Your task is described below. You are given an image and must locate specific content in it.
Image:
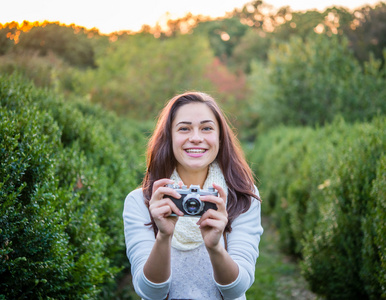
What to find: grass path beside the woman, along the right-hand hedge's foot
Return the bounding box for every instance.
[247,217,322,300]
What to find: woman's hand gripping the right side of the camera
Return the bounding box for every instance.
[197,184,228,251]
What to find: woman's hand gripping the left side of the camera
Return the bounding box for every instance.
[149,178,183,237]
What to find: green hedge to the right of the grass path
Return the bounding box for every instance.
[250,117,386,299]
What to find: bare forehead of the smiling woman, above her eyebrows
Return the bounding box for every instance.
[173,103,217,124]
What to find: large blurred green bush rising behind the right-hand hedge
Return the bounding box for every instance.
[246,34,386,132]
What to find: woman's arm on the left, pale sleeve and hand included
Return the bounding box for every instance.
[123,179,181,299]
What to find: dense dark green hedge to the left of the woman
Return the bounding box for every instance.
[0,75,147,299]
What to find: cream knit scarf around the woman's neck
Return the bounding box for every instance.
[170,161,228,251]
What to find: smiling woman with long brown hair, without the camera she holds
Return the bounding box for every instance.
[123,92,263,300]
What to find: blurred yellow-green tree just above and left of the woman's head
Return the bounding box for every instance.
[78,33,213,120]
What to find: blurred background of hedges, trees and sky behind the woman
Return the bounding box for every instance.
[0,0,386,299]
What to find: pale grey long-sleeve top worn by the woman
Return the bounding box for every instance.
[123,189,263,300]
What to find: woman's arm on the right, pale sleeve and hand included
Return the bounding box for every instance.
[199,186,263,299]
